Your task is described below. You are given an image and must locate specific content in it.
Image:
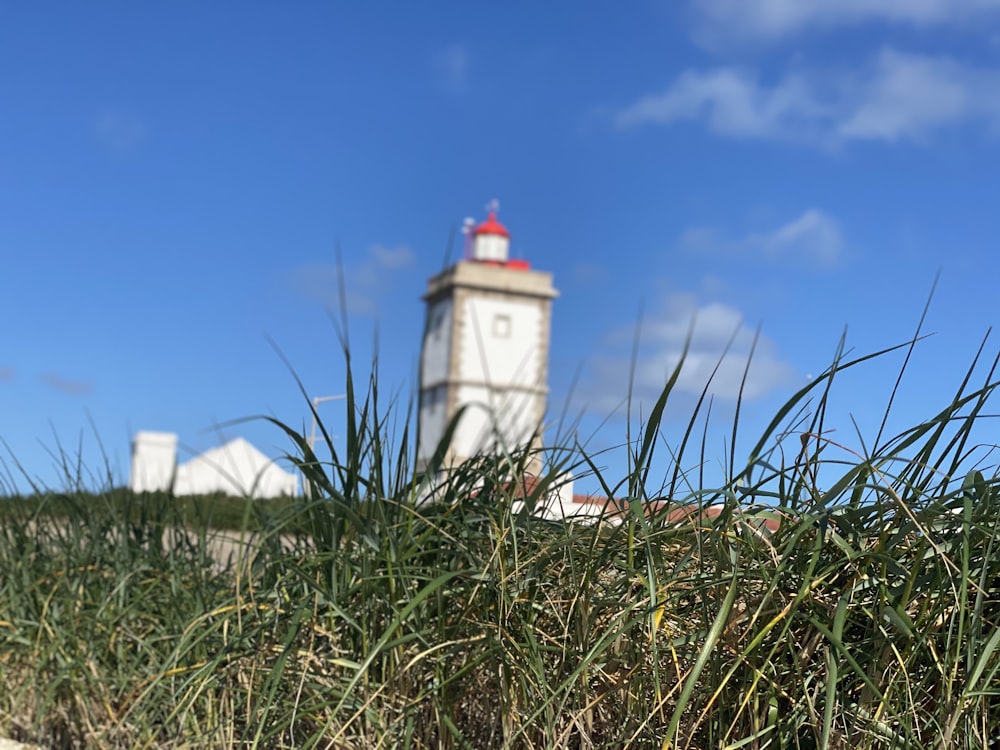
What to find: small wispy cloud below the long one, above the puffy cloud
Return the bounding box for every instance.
[679,208,844,268]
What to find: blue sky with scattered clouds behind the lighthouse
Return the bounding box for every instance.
[0,0,1000,496]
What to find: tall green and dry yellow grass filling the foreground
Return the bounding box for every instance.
[0,332,1000,750]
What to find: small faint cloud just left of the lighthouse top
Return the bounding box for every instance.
[291,245,417,315]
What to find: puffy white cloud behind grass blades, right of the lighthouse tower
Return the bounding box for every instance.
[585,294,796,412]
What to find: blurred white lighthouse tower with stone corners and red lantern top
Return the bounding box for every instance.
[417,201,558,473]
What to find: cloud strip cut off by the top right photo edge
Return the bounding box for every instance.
[691,0,1000,42]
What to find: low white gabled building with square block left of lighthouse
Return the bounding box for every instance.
[129,432,298,498]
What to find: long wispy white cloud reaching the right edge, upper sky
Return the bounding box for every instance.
[616,49,1000,146]
